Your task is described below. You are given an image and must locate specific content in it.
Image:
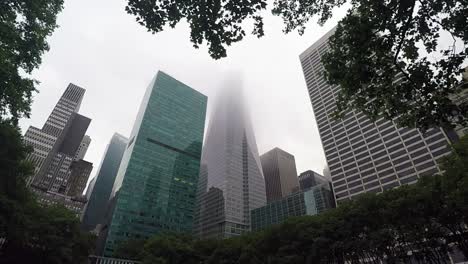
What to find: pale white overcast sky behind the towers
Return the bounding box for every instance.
[20,0,345,186]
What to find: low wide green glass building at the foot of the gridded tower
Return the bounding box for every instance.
[251,182,334,231]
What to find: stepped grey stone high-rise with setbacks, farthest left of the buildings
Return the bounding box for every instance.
[24,84,93,214]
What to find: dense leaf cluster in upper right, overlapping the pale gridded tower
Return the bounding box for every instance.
[324,0,468,128]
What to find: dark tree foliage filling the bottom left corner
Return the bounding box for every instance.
[0,120,94,264]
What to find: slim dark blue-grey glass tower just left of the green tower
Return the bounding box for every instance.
[82,133,128,230]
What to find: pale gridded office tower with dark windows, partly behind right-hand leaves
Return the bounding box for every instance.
[299,30,450,202]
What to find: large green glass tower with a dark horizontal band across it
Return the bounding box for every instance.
[104,72,207,255]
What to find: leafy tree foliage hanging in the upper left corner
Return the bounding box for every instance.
[0,0,63,123]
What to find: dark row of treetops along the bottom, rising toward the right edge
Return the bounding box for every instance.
[114,137,468,264]
